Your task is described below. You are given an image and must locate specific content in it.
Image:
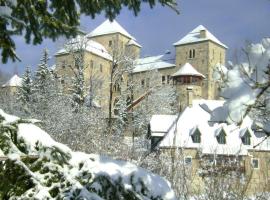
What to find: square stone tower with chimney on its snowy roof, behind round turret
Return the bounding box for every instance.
[174,25,227,99]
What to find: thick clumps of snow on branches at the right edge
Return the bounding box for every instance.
[213,38,270,135]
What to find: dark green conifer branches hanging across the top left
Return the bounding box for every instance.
[0,0,176,63]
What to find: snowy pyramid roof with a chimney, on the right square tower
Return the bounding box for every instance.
[173,25,228,49]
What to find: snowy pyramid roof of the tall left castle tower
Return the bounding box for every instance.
[87,19,135,39]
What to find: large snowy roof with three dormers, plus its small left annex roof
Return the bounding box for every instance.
[150,100,270,155]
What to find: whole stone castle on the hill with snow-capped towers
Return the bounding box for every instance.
[55,20,227,110]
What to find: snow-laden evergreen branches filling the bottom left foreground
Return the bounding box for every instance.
[0,110,176,200]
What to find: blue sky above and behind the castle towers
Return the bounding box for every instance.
[0,0,270,74]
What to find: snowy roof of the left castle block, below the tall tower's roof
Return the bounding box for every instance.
[55,35,112,60]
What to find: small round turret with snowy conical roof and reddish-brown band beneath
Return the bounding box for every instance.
[172,63,205,110]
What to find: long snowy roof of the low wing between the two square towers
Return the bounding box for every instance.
[133,55,175,73]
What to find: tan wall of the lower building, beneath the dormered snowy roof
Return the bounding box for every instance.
[161,148,270,196]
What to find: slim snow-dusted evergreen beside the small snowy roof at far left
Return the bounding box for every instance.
[18,66,33,108]
